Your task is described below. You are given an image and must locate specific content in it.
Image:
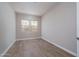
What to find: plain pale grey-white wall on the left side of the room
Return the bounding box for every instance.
[0,2,15,55]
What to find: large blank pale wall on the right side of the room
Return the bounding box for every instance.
[42,2,77,54]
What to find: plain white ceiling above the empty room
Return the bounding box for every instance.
[10,2,56,16]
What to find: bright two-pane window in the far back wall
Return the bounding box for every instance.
[21,20,38,31]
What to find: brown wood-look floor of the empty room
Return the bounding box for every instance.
[4,39,73,57]
